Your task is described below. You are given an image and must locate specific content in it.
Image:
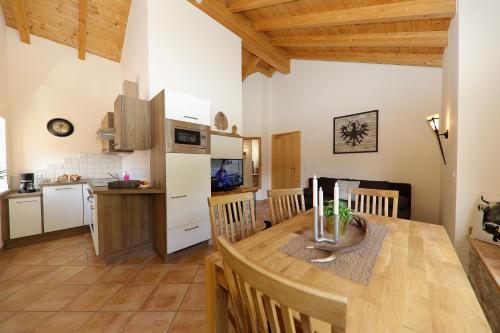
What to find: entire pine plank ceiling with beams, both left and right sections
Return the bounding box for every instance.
[0,0,456,79]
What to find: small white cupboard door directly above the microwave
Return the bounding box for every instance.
[165,90,210,125]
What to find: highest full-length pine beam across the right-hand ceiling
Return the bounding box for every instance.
[253,0,456,31]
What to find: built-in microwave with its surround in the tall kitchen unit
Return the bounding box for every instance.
[165,119,210,154]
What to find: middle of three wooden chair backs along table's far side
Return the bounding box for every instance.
[267,188,306,225]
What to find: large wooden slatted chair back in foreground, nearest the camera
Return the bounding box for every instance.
[219,237,347,333]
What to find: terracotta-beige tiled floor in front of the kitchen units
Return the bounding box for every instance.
[0,202,268,333]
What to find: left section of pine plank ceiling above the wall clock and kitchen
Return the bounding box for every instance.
[0,0,131,62]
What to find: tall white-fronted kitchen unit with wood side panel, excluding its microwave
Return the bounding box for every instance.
[149,90,211,255]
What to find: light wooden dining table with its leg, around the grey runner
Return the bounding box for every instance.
[205,210,491,333]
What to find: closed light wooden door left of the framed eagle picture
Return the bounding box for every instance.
[271,131,301,189]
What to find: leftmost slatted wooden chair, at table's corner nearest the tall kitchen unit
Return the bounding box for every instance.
[208,193,257,247]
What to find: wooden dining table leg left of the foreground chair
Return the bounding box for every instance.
[205,258,229,333]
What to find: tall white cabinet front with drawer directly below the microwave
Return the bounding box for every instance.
[166,153,211,253]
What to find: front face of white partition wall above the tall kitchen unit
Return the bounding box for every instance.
[149,0,242,133]
